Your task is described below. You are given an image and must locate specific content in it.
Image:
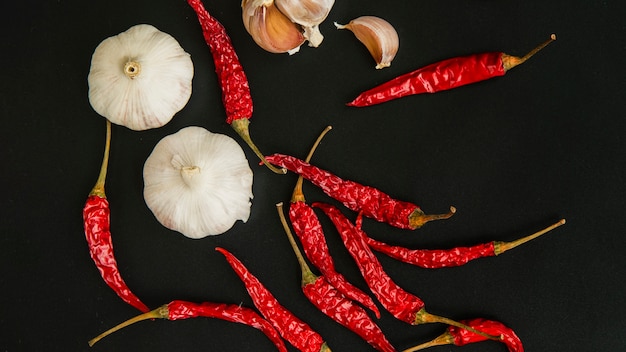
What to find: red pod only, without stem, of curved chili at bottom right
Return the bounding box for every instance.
[446,318,524,352]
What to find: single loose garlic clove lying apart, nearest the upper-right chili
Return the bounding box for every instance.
[335,16,400,69]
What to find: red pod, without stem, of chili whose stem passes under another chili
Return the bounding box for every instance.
[289,201,380,318]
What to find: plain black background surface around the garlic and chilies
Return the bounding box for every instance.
[0,0,626,352]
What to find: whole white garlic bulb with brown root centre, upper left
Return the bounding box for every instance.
[87,24,194,131]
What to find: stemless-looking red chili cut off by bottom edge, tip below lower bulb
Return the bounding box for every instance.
[215,247,330,352]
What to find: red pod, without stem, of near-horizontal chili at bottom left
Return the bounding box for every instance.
[167,300,287,352]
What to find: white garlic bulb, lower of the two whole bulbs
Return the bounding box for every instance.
[143,126,252,238]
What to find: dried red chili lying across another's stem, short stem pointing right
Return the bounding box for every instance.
[266,154,456,230]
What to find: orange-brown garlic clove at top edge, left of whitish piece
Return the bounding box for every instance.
[241,0,305,55]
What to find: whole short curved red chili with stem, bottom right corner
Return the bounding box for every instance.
[402,318,524,352]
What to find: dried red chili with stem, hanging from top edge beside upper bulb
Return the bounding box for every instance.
[187,0,286,174]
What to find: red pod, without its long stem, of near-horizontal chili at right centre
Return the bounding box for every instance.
[366,236,496,269]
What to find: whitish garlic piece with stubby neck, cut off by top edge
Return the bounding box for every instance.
[275,0,335,47]
